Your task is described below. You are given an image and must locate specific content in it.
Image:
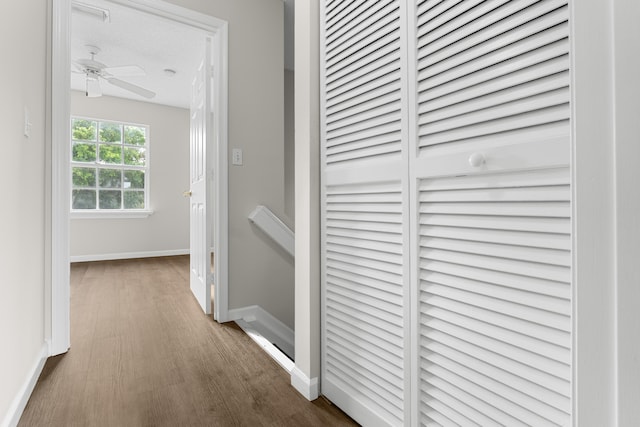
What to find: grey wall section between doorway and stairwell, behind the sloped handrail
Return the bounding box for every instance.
[165,0,294,328]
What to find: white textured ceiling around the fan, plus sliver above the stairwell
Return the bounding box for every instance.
[71,0,294,108]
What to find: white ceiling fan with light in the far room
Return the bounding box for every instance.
[72,45,156,99]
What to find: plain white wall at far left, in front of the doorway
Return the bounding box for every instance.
[0,0,47,425]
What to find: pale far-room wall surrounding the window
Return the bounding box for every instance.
[70,91,189,259]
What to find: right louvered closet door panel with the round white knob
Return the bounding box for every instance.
[410,0,572,426]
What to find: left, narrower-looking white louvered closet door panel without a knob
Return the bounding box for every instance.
[321,0,409,425]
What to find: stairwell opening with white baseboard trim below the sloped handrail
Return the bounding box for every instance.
[227,305,295,372]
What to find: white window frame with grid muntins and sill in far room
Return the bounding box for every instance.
[69,115,153,219]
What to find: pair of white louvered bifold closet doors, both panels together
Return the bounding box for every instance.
[321,0,573,425]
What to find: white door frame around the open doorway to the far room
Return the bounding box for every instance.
[50,0,229,356]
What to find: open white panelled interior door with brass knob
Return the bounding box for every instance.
[190,39,213,314]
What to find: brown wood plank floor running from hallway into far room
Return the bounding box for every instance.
[19,256,356,427]
